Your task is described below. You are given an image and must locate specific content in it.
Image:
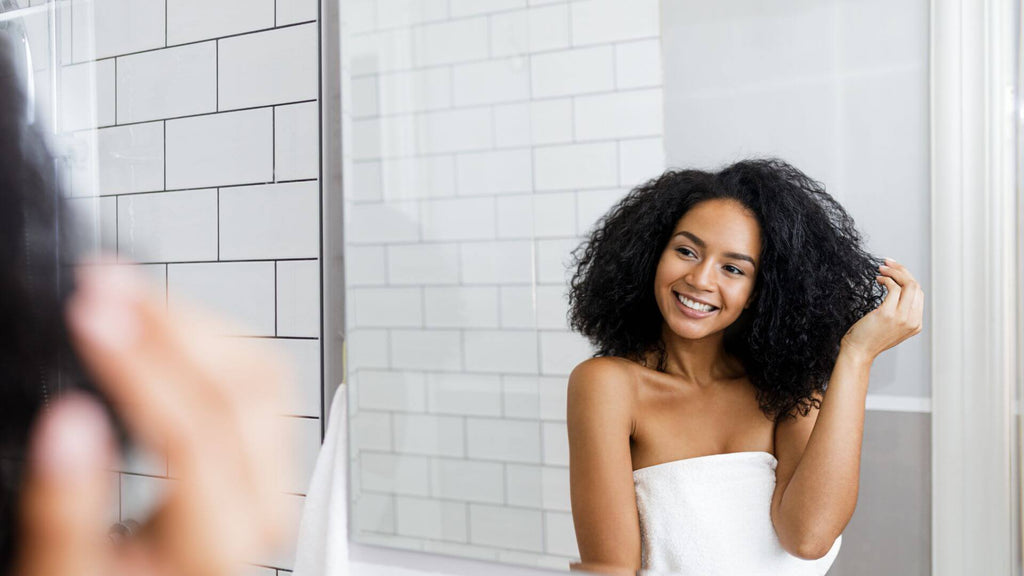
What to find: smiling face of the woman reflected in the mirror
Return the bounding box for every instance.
[654,199,761,339]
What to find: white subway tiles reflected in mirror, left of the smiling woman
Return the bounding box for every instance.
[344,0,665,570]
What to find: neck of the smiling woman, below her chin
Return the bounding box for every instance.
[662,326,741,388]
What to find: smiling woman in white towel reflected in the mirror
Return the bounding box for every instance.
[568,160,924,575]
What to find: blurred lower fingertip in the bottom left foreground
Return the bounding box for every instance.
[14,393,115,576]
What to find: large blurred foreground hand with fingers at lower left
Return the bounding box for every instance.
[15,266,289,576]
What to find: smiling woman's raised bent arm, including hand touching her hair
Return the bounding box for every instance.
[771,260,925,559]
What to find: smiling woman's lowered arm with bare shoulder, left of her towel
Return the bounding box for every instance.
[567,358,640,574]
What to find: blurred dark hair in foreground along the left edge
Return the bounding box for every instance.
[0,38,95,574]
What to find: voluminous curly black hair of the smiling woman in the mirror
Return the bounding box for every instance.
[568,159,885,421]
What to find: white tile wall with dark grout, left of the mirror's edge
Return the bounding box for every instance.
[66,0,321,576]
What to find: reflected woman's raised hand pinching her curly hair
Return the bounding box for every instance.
[842,258,925,362]
